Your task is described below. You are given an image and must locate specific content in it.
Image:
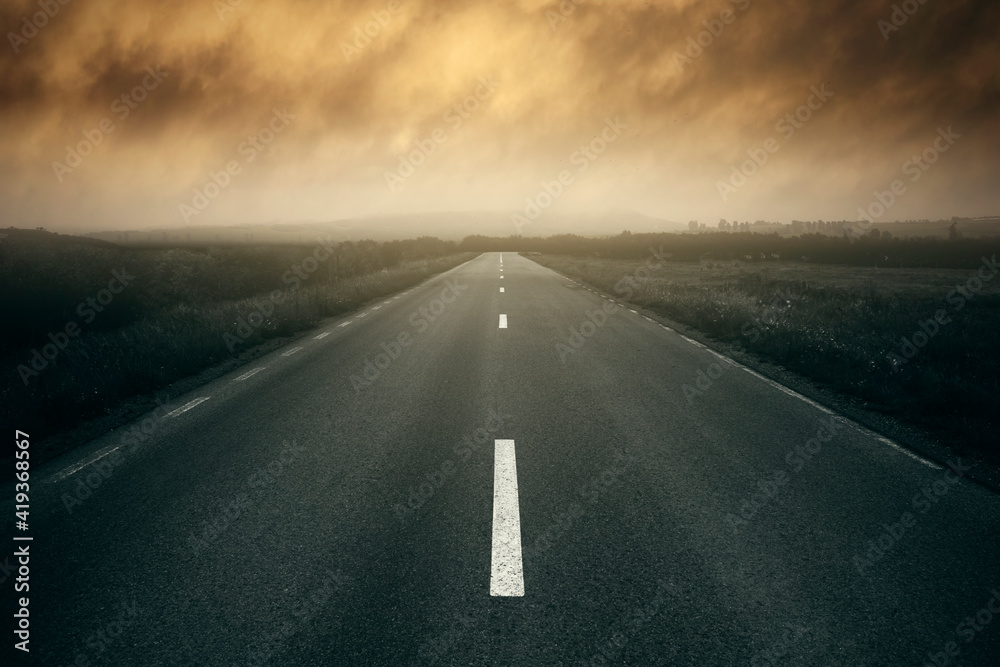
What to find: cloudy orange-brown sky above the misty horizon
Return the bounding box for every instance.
[0,0,1000,234]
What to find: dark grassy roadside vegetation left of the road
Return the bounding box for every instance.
[0,229,474,462]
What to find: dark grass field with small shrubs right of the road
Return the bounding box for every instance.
[532,254,1000,462]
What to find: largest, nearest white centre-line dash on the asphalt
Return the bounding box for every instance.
[490,440,524,597]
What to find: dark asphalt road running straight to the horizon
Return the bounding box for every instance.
[4,253,1000,666]
